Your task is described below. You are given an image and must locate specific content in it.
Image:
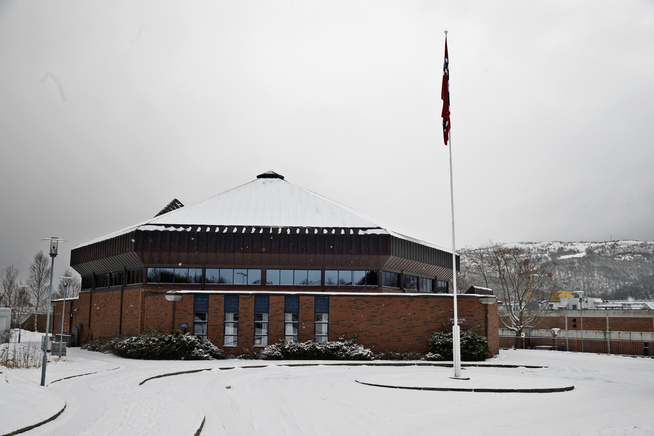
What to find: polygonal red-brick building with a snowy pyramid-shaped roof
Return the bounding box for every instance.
[65,172,498,353]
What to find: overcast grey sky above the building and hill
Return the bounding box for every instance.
[0,0,654,278]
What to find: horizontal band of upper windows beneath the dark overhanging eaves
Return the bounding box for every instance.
[82,268,448,293]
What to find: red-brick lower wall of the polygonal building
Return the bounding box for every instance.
[55,288,499,354]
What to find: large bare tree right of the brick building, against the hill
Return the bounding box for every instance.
[467,244,556,341]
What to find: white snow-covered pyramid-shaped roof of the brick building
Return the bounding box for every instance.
[78,171,448,249]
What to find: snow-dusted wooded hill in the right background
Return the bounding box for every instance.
[460,241,654,300]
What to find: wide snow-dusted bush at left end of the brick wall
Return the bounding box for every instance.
[86,330,225,360]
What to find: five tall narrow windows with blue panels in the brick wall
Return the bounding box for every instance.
[193,295,329,347]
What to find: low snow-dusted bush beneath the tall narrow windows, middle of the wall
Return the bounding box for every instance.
[261,339,373,360]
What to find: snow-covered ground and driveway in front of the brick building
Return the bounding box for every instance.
[0,335,654,436]
